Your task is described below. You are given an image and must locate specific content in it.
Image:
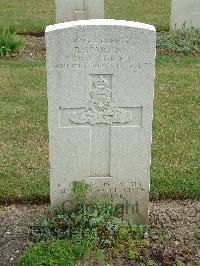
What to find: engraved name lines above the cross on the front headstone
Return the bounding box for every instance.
[54,35,152,72]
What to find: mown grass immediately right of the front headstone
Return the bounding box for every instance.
[151,56,200,198]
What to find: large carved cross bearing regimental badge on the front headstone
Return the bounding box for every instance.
[60,75,142,178]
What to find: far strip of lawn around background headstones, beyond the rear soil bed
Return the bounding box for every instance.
[0,0,171,32]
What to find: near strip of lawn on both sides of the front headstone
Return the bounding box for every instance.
[0,56,200,201]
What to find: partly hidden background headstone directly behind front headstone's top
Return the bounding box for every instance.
[56,0,104,23]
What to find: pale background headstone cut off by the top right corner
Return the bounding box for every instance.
[170,0,200,30]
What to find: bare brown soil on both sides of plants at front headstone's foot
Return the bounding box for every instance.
[0,200,200,266]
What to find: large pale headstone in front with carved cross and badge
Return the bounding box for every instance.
[46,20,156,222]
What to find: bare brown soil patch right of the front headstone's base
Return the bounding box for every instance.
[149,200,200,266]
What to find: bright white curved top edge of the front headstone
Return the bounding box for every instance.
[45,19,156,33]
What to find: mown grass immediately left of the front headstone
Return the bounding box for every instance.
[0,60,49,200]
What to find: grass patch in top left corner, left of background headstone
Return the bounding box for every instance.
[0,0,55,32]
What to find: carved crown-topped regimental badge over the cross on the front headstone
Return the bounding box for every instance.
[70,75,133,125]
